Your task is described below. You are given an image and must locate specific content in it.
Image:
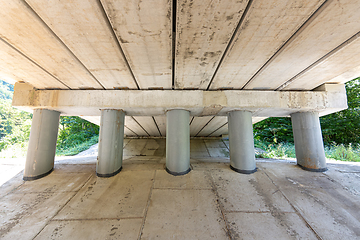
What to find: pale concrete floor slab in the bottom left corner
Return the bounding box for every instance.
[0,192,75,239]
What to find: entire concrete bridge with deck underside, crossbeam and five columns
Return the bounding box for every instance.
[0,0,360,178]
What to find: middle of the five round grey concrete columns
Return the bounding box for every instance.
[166,109,191,176]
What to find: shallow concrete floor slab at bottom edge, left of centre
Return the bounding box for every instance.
[35,219,142,240]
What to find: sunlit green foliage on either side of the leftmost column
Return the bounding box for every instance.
[0,80,99,157]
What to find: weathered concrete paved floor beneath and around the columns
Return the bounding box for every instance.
[0,139,360,239]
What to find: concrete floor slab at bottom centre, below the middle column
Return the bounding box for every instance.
[141,189,229,239]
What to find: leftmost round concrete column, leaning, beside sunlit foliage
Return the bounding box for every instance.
[23,109,60,181]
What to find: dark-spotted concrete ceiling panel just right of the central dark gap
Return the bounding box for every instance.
[175,0,248,89]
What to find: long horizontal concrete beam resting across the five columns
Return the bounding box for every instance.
[13,83,347,117]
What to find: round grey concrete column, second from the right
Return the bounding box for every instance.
[228,111,256,174]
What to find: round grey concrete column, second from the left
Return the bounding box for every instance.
[96,109,125,177]
